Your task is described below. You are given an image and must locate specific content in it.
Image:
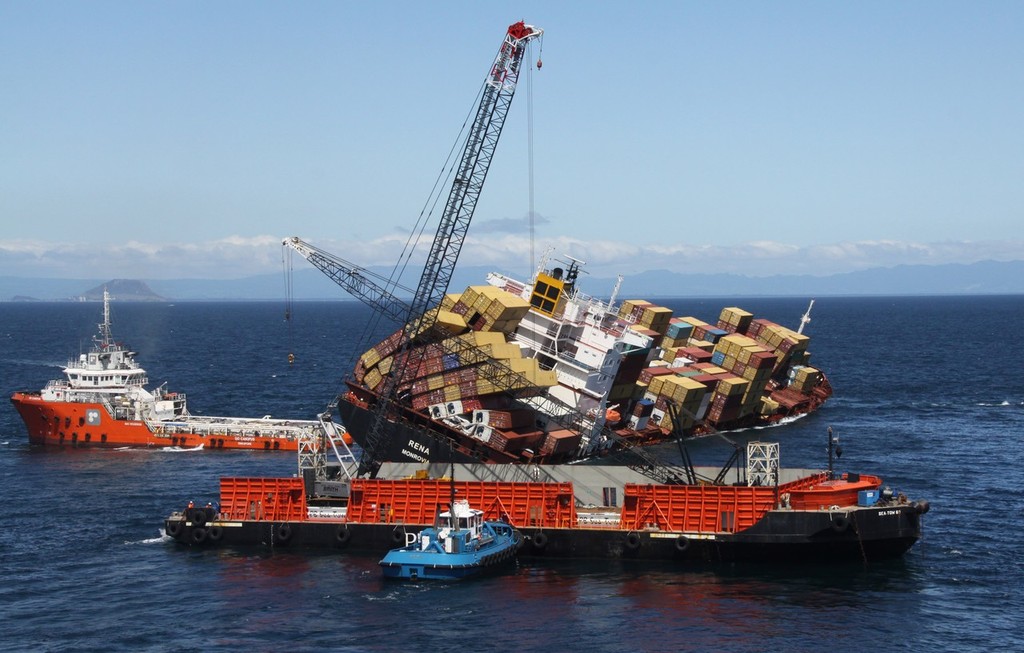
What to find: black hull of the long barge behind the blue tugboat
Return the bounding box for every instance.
[165,505,922,563]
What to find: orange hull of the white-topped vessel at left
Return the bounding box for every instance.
[10,392,298,451]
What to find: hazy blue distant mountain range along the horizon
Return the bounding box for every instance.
[0,261,1024,301]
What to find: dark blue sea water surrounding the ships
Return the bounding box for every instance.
[0,297,1024,653]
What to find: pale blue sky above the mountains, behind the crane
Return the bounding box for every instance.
[0,0,1024,279]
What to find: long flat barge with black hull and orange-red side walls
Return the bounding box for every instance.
[164,442,929,563]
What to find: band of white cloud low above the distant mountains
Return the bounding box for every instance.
[0,232,1024,279]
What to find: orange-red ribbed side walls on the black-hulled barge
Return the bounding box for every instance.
[220,473,881,533]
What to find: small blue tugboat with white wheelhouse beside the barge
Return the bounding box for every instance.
[380,500,522,580]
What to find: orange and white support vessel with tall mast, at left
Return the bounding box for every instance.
[10,290,318,451]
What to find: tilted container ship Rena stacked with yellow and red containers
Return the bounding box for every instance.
[338,259,831,464]
